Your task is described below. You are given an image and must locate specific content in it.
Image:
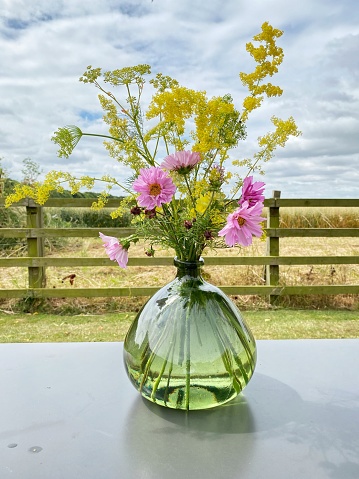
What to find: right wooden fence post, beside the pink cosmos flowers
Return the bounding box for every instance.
[265,190,280,304]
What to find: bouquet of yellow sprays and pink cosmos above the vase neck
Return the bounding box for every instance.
[6,22,300,267]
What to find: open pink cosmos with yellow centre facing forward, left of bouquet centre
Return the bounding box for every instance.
[133,166,176,210]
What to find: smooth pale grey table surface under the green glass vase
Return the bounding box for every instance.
[0,339,359,479]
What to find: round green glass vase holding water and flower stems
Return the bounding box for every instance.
[124,259,256,410]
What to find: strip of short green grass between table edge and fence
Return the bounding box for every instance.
[0,309,359,343]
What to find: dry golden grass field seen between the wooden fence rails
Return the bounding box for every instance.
[0,208,359,313]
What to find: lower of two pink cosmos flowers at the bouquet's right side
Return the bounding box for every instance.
[218,201,264,246]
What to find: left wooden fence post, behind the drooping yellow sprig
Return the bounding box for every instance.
[26,204,46,288]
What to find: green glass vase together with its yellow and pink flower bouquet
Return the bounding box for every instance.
[7,23,300,410]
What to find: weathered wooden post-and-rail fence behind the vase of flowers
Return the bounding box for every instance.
[0,191,359,302]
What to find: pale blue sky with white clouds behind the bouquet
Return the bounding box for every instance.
[0,0,359,198]
